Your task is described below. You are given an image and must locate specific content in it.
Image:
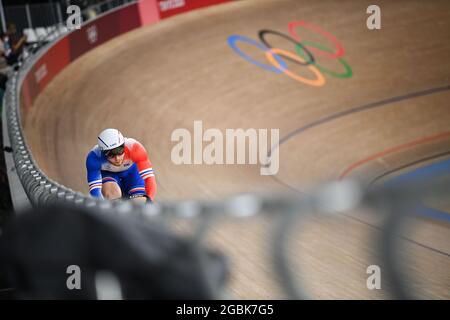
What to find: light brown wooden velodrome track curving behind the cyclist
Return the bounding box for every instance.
[19,0,450,299]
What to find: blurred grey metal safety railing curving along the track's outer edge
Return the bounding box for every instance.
[4,0,450,299]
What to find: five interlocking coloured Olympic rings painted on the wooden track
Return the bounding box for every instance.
[228,21,353,87]
